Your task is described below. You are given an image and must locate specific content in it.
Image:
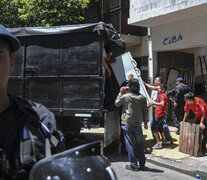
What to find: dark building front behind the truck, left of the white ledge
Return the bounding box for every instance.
[85,0,148,80]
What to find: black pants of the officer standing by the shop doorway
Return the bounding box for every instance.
[172,104,184,129]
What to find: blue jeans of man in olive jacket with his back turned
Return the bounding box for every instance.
[122,125,146,168]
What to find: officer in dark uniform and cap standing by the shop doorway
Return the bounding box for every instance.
[171,77,190,134]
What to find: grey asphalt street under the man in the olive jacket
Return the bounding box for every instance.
[108,155,196,180]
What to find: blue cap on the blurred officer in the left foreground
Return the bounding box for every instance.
[0,24,21,52]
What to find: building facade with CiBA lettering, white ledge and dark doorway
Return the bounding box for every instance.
[128,0,207,95]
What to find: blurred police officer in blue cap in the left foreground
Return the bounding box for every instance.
[0,24,63,180]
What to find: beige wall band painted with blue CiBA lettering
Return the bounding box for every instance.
[152,16,207,51]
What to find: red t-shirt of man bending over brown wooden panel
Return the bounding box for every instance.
[184,97,207,120]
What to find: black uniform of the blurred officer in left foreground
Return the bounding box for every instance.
[0,96,63,180]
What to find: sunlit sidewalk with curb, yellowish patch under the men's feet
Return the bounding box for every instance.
[143,126,207,180]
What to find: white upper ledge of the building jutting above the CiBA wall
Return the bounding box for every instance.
[128,0,207,27]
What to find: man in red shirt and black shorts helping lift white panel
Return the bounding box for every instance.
[150,84,168,149]
